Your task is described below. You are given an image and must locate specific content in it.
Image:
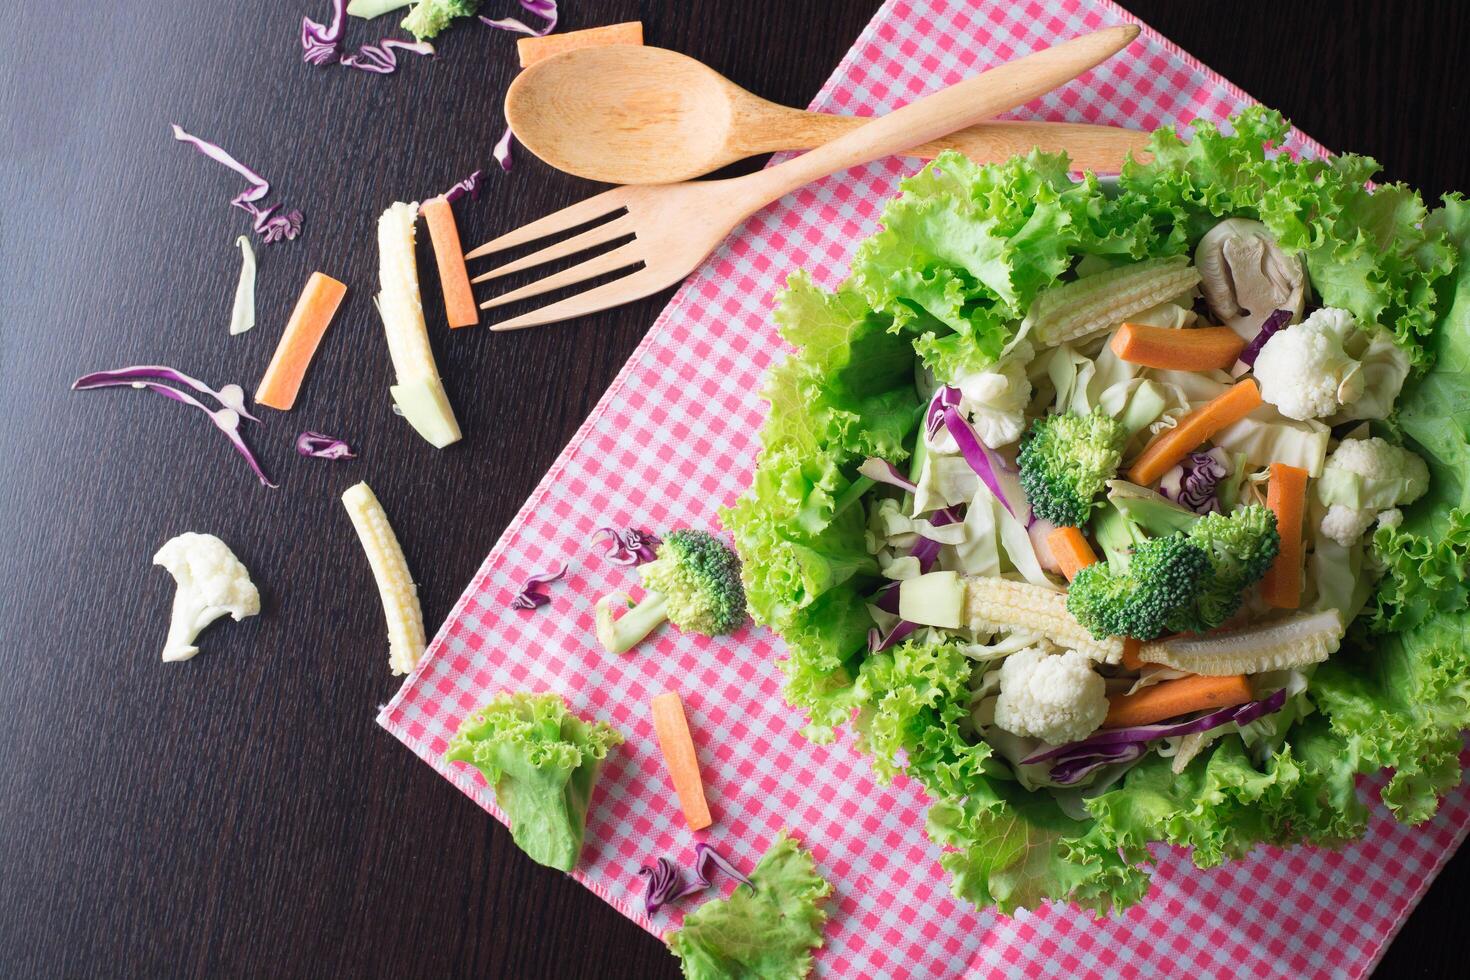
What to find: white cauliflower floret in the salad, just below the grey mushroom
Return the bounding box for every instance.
[1254,307,1363,420]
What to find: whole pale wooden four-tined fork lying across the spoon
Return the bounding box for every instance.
[465,25,1138,331]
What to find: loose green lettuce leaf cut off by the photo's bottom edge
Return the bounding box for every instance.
[667,835,832,980]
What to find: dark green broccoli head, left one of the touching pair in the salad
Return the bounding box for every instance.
[1067,535,1210,639]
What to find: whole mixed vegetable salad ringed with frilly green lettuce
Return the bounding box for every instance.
[723,107,1470,912]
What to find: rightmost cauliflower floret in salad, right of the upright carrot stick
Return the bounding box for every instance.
[1317,436,1429,548]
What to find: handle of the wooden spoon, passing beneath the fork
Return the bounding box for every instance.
[741,116,1151,173]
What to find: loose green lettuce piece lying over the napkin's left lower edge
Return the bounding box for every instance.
[444,692,623,871]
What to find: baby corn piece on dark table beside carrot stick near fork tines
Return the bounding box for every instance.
[376,201,462,450]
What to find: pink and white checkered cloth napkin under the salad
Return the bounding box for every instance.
[378,0,1470,977]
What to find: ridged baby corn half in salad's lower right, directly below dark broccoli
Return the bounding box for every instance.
[1139,610,1344,676]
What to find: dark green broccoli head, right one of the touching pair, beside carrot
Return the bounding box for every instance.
[1169,504,1282,633]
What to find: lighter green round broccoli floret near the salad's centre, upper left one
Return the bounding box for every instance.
[1019,410,1127,527]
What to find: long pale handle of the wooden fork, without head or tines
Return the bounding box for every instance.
[731,24,1138,212]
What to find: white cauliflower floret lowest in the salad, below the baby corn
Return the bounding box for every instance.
[995,646,1107,745]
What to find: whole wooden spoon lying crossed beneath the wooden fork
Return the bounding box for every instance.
[506,44,1148,184]
